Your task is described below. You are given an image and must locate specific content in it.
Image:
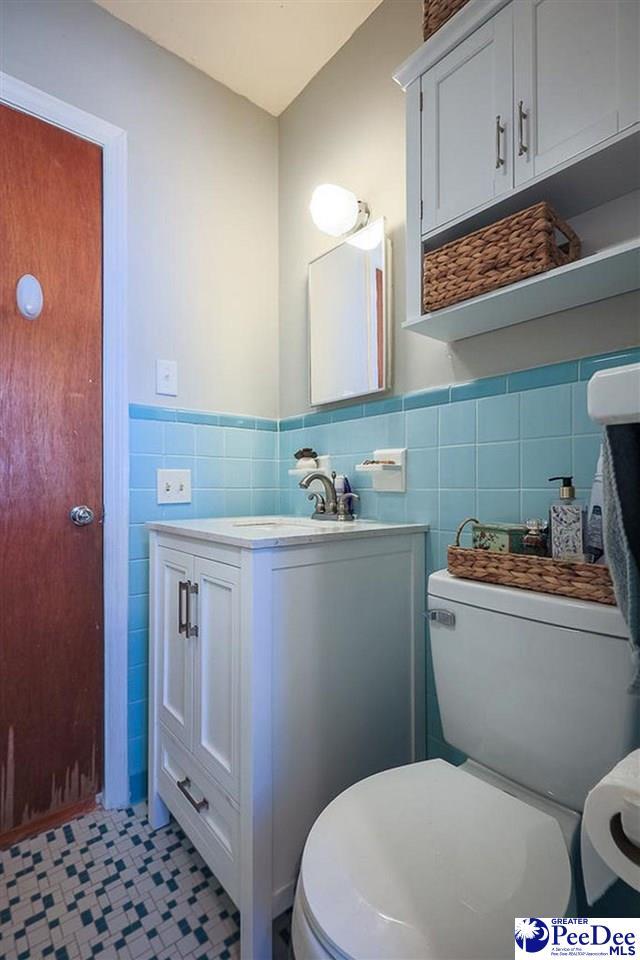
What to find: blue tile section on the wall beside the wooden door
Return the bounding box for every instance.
[128,404,279,803]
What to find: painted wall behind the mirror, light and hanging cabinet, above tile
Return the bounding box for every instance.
[279,0,640,417]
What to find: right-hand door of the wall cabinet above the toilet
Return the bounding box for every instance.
[513,0,640,184]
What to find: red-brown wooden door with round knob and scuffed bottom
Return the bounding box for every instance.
[0,105,103,844]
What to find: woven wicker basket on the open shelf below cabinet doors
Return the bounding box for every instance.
[422,202,580,313]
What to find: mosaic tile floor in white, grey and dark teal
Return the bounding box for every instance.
[0,808,288,960]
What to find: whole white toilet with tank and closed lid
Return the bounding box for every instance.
[292,571,639,960]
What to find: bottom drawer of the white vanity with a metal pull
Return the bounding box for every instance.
[158,724,240,903]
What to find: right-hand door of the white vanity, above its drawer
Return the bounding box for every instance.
[193,558,240,799]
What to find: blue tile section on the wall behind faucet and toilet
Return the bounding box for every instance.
[280,349,640,762]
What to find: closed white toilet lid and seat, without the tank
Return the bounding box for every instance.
[297,760,571,960]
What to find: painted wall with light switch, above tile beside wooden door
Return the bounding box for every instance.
[0,0,278,416]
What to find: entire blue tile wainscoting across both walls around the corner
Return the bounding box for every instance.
[129,349,640,802]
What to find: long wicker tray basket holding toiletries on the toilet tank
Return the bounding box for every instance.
[447,520,616,606]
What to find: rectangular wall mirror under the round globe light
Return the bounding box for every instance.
[309,219,391,406]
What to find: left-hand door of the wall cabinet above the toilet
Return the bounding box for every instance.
[422,4,513,234]
